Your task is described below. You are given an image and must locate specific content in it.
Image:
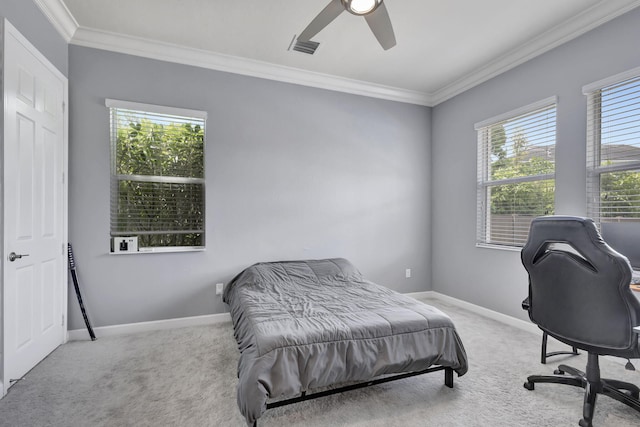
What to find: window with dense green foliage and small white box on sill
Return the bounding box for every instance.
[106,99,206,253]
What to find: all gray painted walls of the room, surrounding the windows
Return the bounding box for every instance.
[16,0,640,329]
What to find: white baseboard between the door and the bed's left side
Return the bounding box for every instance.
[67,313,231,341]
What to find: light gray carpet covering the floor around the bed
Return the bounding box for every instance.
[0,299,640,427]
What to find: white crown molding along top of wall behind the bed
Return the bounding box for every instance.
[71,27,431,106]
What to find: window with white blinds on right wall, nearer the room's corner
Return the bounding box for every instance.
[475,97,556,247]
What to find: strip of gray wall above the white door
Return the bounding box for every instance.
[0,0,69,76]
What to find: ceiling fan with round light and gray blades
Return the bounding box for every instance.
[298,0,396,50]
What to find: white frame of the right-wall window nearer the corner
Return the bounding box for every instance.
[474,96,558,251]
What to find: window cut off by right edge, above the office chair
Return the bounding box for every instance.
[583,68,640,268]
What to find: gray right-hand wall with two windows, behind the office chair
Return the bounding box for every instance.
[431,9,640,319]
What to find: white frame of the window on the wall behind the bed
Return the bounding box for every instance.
[105,98,207,255]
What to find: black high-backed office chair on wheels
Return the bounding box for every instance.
[521,216,640,427]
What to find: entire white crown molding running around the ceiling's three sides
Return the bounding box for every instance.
[34,0,640,107]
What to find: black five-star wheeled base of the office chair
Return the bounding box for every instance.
[524,362,640,427]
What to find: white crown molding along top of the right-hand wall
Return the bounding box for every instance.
[431,0,640,106]
